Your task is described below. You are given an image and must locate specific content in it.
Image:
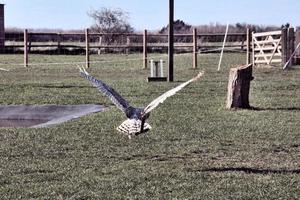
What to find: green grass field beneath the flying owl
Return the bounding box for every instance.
[0,54,300,200]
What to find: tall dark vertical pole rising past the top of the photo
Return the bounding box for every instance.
[168,0,174,82]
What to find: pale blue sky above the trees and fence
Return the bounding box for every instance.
[0,0,300,30]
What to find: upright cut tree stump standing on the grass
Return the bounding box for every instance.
[226,64,253,109]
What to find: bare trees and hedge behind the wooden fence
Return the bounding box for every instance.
[6,8,300,45]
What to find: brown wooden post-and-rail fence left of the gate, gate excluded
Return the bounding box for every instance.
[5,29,247,68]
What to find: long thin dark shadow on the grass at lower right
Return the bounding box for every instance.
[200,167,300,174]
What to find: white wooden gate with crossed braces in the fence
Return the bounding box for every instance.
[252,31,282,65]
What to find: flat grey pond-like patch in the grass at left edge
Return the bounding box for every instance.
[0,104,105,128]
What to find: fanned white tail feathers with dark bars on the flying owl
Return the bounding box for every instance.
[117,119,151,139]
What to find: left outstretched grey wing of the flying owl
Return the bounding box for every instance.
[79,68,130,112]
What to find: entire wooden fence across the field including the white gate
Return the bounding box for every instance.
[1,28,300,68]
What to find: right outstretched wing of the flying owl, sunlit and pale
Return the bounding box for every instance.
[144,72,204,115]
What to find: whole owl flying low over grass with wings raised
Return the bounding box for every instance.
[80,67,204,139]
